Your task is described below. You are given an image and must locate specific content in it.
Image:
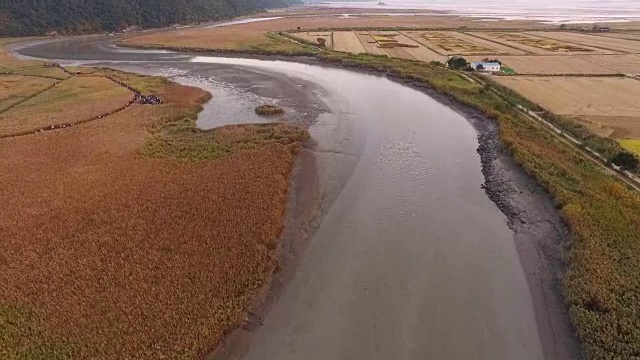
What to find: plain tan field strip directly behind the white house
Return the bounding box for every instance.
[484,55,618,75]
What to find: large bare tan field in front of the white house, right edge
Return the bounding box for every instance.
[495,76,640,139]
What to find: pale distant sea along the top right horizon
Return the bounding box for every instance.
[321,0,640,24]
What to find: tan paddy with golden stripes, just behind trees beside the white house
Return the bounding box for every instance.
[405,31,496,55]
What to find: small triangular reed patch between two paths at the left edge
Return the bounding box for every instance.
[0,75,56,114]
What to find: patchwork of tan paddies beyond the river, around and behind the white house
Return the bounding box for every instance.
[291,30,640,75]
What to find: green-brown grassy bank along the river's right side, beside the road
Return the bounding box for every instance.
[319,53,640,360]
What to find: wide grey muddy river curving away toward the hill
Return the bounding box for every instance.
[12,37,570,360]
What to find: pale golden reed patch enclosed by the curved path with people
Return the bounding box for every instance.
[0,77,133,136]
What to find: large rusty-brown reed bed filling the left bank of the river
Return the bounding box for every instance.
[0,50,309,360]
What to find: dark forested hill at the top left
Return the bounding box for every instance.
[0,0,291,36]
